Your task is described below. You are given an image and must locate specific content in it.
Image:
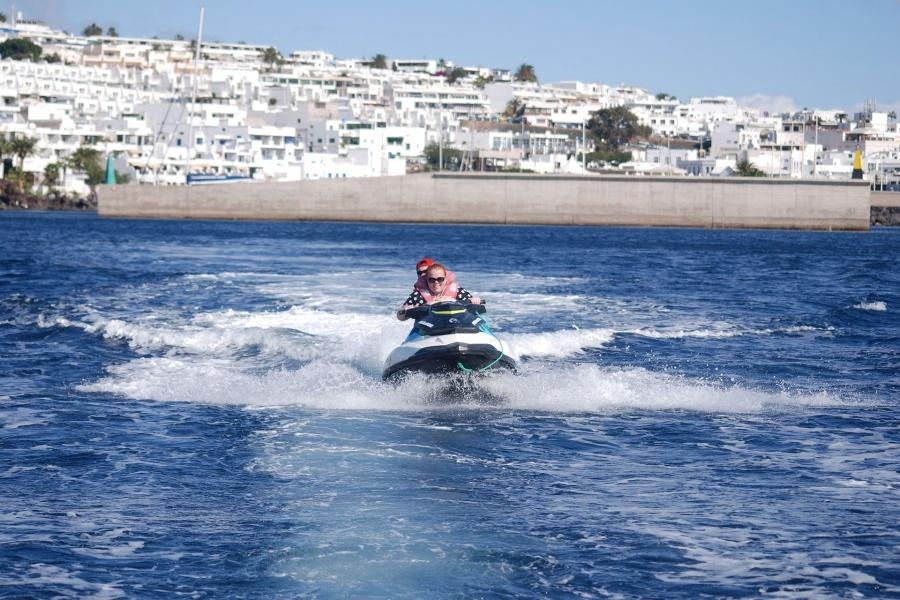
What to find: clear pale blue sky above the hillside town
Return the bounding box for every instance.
[12,0,900,111]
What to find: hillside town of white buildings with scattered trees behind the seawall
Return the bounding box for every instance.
[0,15,900,196]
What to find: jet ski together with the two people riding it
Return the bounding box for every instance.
[382,263,516,379]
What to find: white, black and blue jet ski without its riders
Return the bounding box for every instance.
[381,302,516,379]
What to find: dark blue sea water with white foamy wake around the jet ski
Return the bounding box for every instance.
[0,213,900,598]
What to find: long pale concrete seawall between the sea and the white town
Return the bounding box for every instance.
[98,173,870,230]
